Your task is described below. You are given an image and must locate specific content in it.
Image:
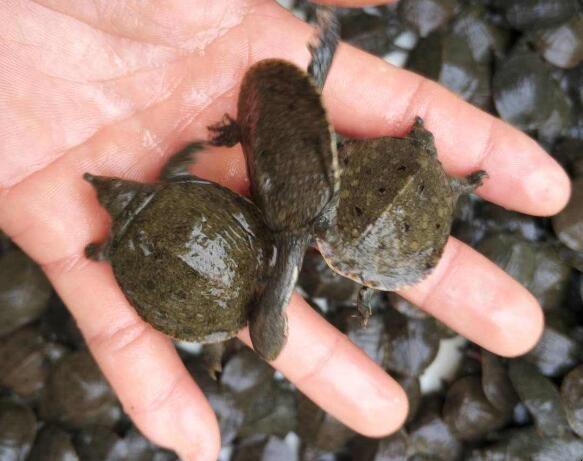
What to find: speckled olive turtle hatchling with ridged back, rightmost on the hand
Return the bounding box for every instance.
[318,117,486,318]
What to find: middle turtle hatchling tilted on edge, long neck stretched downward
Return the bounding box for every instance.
[209,9,339,360]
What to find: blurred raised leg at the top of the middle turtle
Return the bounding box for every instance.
[308,7,340,91]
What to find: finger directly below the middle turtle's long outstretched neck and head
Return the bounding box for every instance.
[239,294,408,437]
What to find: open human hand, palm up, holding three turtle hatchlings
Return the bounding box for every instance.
[0,0,569,460]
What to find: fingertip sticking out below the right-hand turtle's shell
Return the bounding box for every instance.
[399,237,544,357]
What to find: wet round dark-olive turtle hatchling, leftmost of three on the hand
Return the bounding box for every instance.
[84,143,274,342]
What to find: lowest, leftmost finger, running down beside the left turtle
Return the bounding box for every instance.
[45,254,220,461]
